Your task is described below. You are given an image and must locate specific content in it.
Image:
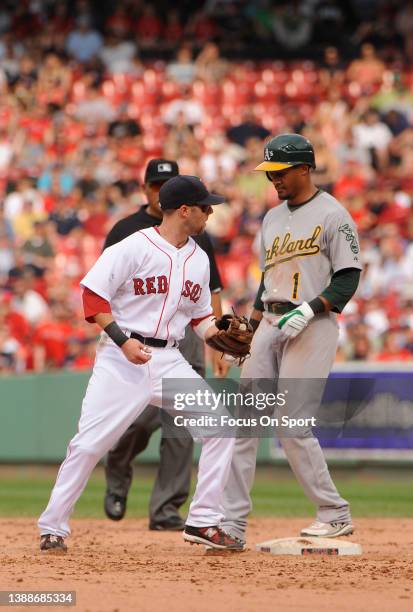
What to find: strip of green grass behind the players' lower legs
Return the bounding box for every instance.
[0,466,413,518]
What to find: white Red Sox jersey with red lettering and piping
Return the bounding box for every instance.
[81,227,212,341]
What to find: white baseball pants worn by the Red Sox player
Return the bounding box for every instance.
[38,341,235,537]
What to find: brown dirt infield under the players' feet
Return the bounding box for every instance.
[0,518,413,612]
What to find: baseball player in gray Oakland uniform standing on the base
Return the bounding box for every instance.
[222,134,361,540]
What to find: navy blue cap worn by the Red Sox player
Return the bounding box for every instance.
[159,174,225,210]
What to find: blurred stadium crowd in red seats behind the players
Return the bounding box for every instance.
[0,0,413,373]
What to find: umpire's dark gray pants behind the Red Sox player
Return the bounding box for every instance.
[105,325,205,525]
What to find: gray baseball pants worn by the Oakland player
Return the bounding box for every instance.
[222,314,351,539]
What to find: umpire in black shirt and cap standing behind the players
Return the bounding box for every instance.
[104,159,228,531]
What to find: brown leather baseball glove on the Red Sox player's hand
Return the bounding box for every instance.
[206,314,254,365]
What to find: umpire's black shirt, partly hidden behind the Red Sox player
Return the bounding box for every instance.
[103,205,222,293]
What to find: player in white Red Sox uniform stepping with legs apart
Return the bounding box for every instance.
[38,175,243,552]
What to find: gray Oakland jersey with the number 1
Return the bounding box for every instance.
[260,191,362,304]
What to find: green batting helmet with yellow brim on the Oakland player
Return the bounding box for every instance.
[255,134,315,172]
